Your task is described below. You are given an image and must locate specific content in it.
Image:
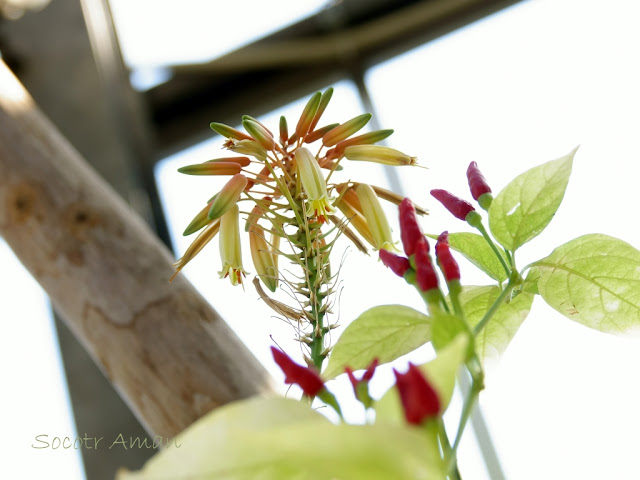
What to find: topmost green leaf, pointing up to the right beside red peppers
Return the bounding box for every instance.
[489,148,577,251]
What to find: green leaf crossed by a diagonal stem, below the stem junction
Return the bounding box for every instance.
[460,286,533,359]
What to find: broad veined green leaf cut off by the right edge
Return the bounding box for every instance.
[533,234,640,333]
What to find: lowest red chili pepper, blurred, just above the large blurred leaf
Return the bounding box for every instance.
[393,363,440,425]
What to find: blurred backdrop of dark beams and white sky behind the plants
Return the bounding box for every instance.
[0,0,640,480]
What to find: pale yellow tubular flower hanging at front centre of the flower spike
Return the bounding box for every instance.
[295,148,336,223]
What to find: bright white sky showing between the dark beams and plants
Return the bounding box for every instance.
[3,0,640,480]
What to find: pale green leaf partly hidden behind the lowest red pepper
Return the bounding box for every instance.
[376,335,469,424]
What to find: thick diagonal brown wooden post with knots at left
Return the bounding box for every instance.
[0,62,272,437]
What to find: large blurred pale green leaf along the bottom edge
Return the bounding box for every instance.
[117,398,445,480]
